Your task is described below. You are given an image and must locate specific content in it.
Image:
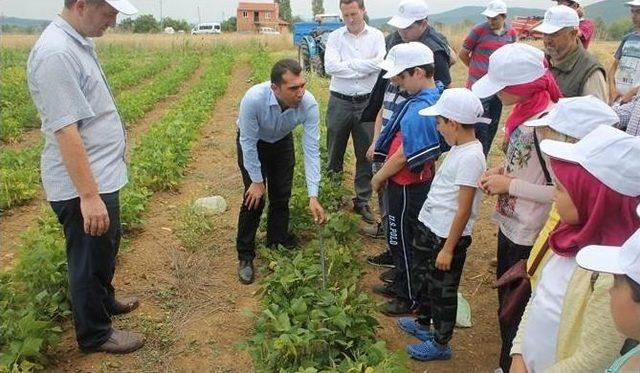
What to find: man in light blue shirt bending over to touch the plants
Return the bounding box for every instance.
[236,59,325,284]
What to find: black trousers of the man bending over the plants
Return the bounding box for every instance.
[236,134,296,260]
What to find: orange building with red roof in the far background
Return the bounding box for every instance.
[236,0,289,32]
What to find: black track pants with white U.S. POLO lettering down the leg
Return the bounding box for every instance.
[387,181,431,306]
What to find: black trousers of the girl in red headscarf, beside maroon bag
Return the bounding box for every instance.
[496,231,532,372]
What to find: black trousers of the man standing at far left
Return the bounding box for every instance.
[51,192,122,349]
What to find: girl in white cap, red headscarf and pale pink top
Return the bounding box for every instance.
[471,43,561,371]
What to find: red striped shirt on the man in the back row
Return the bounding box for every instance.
[462,22,517,89]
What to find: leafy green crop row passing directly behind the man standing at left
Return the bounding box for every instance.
[0,48,233,371]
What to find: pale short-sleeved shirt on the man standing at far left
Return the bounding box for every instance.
[27,17,127,201]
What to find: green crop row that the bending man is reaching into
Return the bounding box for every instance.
[242,49,407,373]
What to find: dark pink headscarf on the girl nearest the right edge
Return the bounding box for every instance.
[549,158,640,257]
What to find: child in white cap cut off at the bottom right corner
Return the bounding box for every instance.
[576,224,640,373]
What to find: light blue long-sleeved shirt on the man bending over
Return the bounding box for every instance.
[237,81,320,197]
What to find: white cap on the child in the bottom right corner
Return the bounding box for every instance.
[576,229,640,284]
